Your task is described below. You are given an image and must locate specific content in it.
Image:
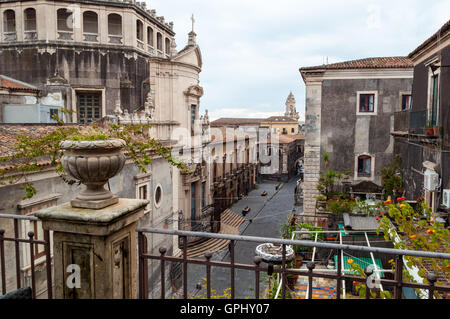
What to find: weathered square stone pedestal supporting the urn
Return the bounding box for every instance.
[36,198,149,299]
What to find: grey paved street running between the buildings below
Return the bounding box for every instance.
[188,177,301,298]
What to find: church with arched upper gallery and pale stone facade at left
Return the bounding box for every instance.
[0,0,213,295]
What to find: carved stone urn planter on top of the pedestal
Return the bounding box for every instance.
[60,139,125,209]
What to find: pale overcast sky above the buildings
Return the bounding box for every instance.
[147,0,450,120]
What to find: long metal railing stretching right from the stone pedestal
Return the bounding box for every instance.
[137,227,450,299]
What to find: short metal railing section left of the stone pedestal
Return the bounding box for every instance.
[0,214,53,299]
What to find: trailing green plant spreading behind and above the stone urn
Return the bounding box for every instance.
[0,110,188,199]
